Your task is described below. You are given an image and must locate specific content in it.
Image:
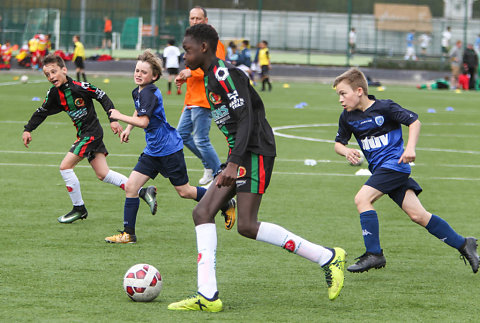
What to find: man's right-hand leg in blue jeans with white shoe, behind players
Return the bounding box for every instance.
[191,107,220,185]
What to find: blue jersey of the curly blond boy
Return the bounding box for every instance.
[132,84,183,157]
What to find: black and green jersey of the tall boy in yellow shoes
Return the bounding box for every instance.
[205,59,276,164]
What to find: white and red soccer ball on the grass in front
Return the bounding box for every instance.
[123,264,162,302]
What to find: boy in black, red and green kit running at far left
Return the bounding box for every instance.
[22,54,157,223]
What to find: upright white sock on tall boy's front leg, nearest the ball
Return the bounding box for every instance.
[195,223,217,298]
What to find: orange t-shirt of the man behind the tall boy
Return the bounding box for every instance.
[185,40,225,109]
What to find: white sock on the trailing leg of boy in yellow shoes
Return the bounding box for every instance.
[256,222,333,266]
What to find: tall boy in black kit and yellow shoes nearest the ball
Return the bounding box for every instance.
[168,24,345,312]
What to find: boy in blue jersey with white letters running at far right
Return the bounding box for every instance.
[333,68,478,273]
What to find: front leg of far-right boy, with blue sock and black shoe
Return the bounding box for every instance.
[347,185,386,272]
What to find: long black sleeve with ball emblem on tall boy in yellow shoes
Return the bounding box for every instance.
[219,68,253,164]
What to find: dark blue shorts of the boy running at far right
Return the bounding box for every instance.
[365,168,422,207]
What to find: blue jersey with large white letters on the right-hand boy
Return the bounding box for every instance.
[335,95,418,173]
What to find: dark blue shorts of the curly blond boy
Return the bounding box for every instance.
[133,149,188,186]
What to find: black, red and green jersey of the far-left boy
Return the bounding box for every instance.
[25,77,114,138]
